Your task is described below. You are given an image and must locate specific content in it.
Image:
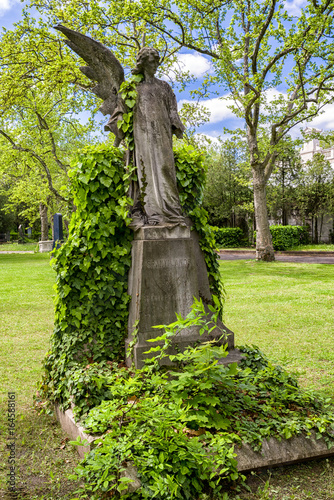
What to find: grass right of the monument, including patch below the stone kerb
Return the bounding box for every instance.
[220,260,334,500]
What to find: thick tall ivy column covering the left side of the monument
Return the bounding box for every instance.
[41,145,133,407]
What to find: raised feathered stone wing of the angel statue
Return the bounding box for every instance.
[54,24,124,115]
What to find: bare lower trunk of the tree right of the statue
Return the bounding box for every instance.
[253,168,275,262]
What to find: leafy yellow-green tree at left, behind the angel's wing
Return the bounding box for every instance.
[0,19,99,235]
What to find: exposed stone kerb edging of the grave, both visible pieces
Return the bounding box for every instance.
[55,406,334,472]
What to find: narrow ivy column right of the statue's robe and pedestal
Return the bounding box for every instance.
[174,143,223,297]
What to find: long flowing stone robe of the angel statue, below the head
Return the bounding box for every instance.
[133,77,185,224]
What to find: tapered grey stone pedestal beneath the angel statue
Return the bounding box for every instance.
[126,226,234,368]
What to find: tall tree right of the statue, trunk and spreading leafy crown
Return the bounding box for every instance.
[5,0,334,260]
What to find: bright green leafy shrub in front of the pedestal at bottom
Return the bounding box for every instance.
[68,301,243,500]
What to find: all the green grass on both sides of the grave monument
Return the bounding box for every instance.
[0,254,334,500]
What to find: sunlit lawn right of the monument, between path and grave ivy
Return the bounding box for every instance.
[220,260,334,398]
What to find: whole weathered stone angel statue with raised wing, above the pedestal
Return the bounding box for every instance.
[55,25,185,227]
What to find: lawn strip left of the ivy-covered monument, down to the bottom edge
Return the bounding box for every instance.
[0,254,78,500]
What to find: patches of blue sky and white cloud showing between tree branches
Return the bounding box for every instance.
[0,0,334,143]
